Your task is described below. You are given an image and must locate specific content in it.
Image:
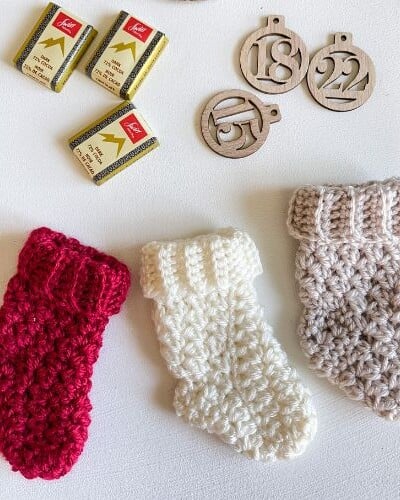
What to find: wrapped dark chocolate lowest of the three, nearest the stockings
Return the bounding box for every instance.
[69,101,159,185]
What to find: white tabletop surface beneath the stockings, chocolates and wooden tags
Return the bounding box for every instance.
[0,0,400,500]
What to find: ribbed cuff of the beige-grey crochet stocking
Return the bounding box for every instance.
[288,178,400,241]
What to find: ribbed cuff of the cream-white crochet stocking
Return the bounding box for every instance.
[141,228,262,300]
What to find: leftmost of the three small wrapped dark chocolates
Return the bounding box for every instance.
[14,2,97,92]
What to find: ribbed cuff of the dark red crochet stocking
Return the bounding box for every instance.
[18,228,130,316]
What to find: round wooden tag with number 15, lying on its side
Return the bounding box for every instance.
[201,90,281,158]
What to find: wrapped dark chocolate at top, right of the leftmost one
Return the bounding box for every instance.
[86,11,168,99]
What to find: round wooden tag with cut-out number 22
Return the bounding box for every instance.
[307,33,375,111]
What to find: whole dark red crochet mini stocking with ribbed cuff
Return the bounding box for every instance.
[0,228,130,479]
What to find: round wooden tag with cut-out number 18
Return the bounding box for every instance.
[240,16,309,94]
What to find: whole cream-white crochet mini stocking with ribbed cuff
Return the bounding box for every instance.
[141,229,316,461]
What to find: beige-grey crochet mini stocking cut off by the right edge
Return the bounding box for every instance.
[288,179,400,419]
